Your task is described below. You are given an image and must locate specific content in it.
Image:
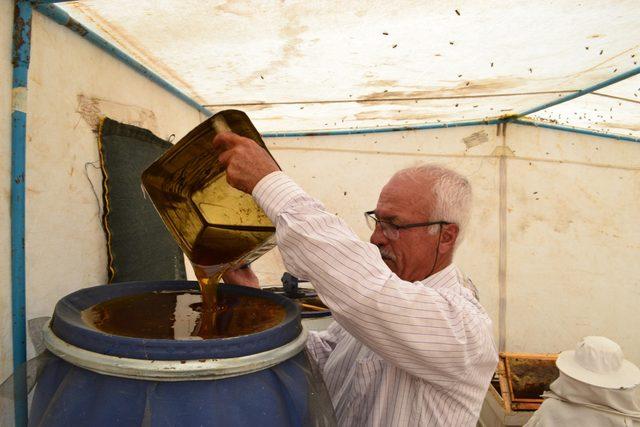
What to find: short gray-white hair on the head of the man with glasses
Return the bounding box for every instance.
[394,164,473,246]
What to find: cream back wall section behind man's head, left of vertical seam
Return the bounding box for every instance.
[254,126,499,341]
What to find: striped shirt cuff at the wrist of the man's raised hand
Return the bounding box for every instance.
[251,171,306,224]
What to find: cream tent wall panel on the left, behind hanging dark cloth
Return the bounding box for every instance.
[16,13,200,362]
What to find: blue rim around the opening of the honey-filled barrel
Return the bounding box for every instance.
[51,280,302,361]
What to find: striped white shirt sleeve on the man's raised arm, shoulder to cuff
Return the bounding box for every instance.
[253,172,497,382]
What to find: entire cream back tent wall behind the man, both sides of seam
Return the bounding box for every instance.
[254,125,640,363]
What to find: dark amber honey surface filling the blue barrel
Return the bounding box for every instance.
[82,291,286,340]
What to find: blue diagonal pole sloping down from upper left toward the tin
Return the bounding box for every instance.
[36,4,213,117]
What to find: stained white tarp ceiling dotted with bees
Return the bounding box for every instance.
[61,0,640,137]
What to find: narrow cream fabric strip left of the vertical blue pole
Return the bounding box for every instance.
[0,0,13,384]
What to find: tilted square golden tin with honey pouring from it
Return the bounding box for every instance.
[142,110,275,320]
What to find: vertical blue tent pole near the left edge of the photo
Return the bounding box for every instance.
[11,0,32,426]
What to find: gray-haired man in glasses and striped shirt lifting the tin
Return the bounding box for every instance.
[213,133,498,426]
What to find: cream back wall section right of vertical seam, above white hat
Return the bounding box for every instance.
[506,126,640,364]
